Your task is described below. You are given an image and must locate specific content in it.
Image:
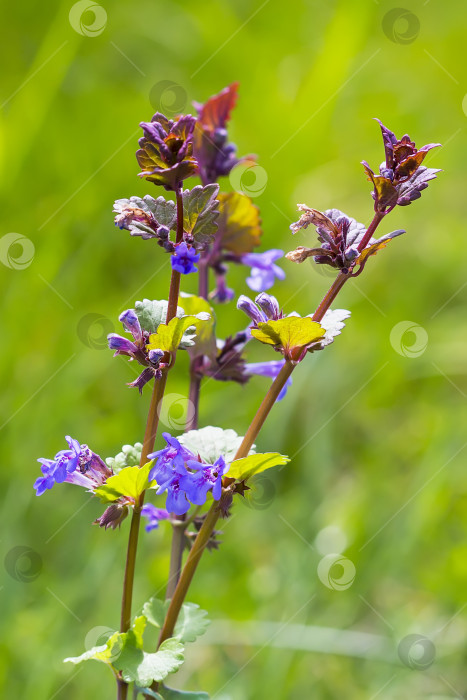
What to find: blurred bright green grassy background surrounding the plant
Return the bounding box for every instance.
[0,0,467,700]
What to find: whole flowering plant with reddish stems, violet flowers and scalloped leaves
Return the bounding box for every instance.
[34,89,439,700]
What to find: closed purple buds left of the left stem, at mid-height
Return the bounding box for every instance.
[107,309,166,394]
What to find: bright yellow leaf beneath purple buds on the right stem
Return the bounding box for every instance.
[251,316,324,356]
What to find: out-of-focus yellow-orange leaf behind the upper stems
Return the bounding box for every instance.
[218,192,262,255]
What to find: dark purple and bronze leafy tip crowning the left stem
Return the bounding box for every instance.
[136,112,197,191]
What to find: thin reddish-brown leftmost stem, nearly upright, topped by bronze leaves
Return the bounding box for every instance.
[117,185,183,700]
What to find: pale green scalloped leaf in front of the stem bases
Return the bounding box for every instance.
[114,633,184,688]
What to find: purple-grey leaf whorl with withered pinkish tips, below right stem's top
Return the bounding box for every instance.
[286,204,404,273]
